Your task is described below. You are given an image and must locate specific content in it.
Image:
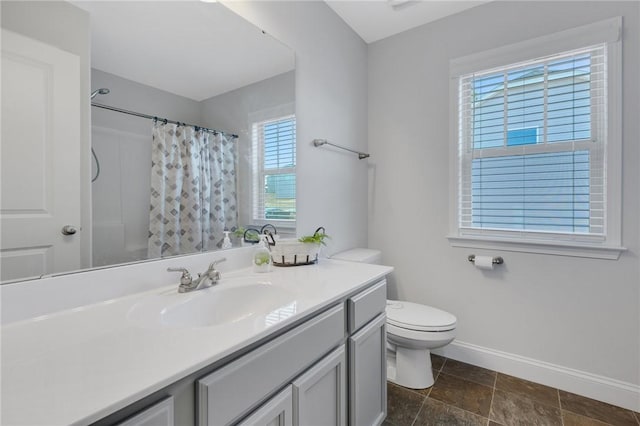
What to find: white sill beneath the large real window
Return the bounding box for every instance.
[447,235,627,260]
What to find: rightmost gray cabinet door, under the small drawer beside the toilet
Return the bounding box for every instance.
[349,314,387,426]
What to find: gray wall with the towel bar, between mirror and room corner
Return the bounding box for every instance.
[223,1,367,254]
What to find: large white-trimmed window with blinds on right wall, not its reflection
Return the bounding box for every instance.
[450,19,620,258]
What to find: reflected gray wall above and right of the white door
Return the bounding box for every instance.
[0,1,91,268]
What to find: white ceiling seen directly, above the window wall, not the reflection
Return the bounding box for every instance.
[325,0,490,43]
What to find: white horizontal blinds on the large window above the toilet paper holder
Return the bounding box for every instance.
[458,44,607,239]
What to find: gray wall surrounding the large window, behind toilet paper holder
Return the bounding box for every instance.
[368,1,640,392]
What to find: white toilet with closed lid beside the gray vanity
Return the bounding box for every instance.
[331,248,456,389]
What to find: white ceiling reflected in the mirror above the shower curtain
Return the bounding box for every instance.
[72,0,295,101]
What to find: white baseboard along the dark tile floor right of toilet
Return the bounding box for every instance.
[432,340,640,412]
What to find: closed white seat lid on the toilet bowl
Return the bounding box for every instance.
[386,300,456,331]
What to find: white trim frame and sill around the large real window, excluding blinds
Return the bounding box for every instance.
[447,17,625,259]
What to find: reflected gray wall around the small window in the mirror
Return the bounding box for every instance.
[201,71,295,233]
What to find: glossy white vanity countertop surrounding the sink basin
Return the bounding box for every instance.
[0,259,392,425]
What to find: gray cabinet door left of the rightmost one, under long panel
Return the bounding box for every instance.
[293,345,347,426]
